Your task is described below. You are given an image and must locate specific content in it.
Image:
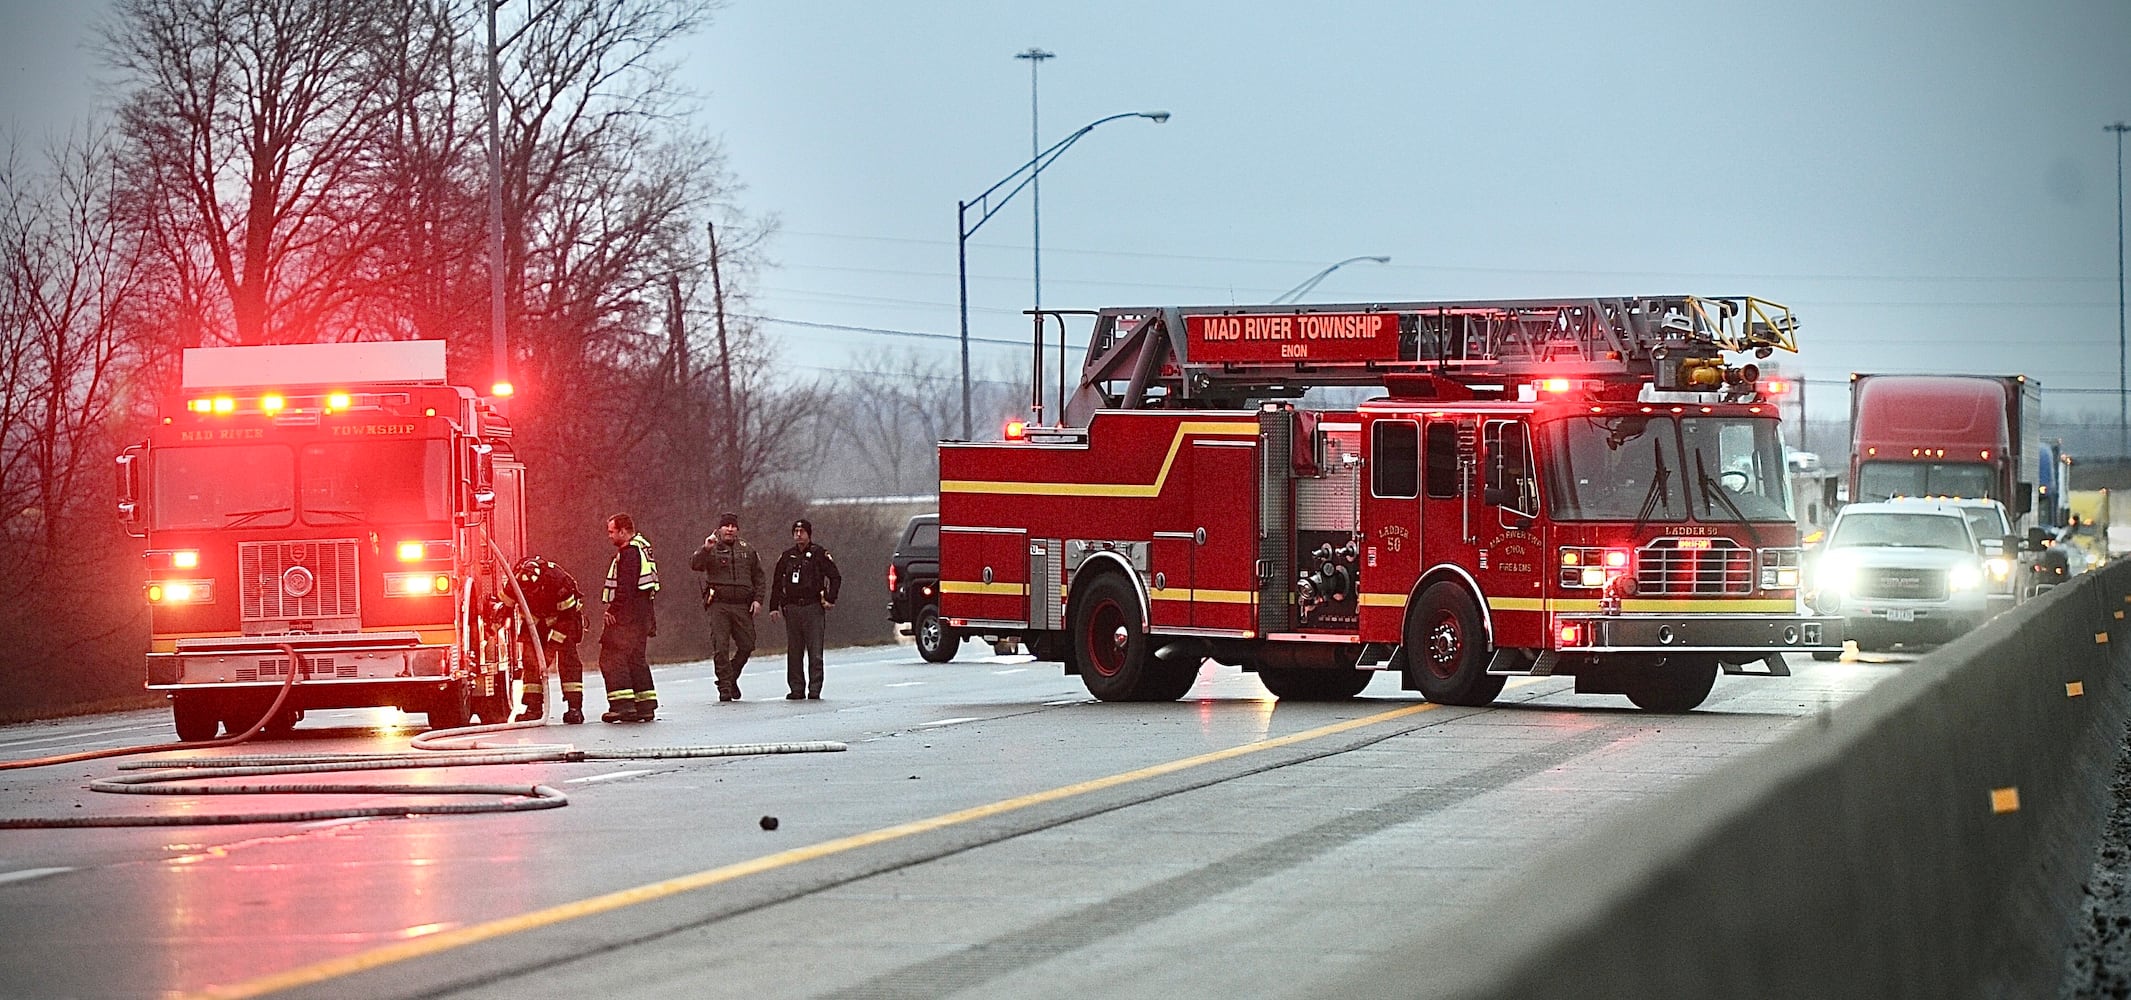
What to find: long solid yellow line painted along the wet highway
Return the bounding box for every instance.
[188,701,1441,1000]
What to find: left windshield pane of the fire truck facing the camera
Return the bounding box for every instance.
[151,443,296,529]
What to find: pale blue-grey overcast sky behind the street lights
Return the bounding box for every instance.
[12,0,2131,416]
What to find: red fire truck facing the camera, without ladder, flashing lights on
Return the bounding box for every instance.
[117,341,524,740]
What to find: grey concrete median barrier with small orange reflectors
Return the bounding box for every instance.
[1328,563,2131,1000]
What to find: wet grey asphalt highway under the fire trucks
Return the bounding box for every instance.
[0,648,1901,998]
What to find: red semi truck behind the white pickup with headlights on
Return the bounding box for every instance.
[1850,373,2044,531]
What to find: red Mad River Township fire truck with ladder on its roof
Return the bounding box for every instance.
[940,296,1841,712]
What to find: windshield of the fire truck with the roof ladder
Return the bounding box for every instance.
[1543,414,1790,522]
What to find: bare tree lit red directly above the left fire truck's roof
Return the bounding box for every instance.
[102,0,409,343]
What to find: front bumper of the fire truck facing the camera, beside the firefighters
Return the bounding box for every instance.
[147,631,456,691]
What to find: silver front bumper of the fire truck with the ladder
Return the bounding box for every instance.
[1553,612,1843,659]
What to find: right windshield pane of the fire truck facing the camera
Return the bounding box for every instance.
[298,439,452,525]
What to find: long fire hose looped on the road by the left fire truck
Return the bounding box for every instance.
[0,530,848,829]
